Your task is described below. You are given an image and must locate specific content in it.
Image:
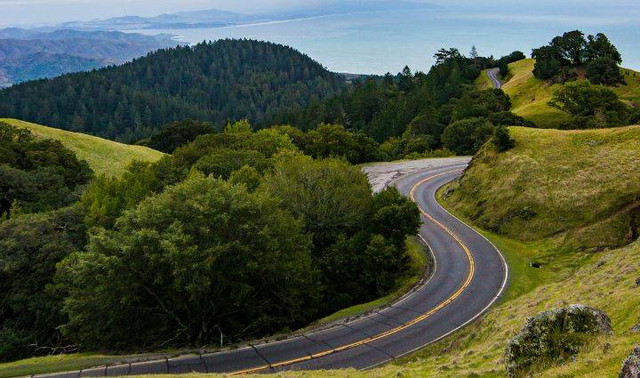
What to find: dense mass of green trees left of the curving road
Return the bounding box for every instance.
[0,122,420,361]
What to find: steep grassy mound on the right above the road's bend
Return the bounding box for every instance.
[448,126,640,248]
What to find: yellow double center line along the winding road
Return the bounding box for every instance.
[229,169,476,375]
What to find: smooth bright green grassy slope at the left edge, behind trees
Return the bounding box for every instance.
[0,118,164,176]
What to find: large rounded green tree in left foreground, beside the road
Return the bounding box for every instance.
[58,175,314,348]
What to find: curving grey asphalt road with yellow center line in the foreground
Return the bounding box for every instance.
[41,161,508,377]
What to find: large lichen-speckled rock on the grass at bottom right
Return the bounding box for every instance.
[505,305,613,377]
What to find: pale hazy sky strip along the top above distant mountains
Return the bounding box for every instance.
[5,0,640,26]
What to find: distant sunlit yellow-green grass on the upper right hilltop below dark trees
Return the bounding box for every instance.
[502,59,640,128]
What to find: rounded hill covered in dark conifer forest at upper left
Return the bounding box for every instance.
[0,40,345,141]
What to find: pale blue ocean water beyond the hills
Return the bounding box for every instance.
[127,2,640,74]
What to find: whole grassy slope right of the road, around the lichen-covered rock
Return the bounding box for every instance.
[412,126,640,377]
